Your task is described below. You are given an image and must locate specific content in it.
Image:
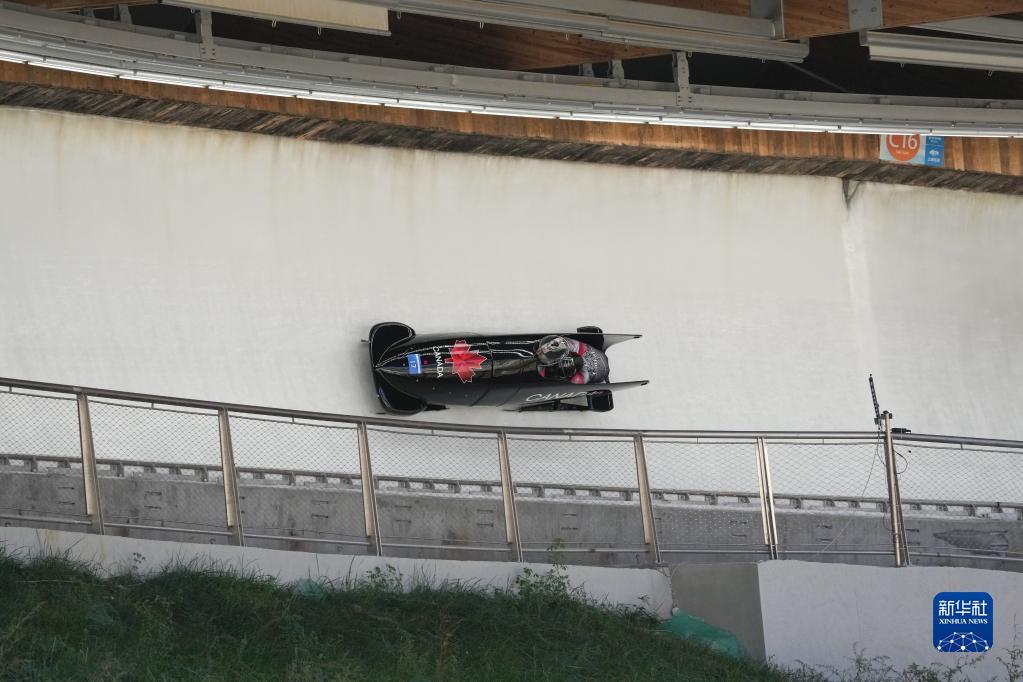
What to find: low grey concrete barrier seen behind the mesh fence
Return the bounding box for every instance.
[0,464,1023,572]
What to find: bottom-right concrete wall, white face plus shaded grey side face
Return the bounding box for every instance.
[671,561,1023,680]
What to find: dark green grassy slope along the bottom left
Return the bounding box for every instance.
[0,554,787,682]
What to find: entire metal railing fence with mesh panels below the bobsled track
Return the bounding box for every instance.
[0,378,1023,570]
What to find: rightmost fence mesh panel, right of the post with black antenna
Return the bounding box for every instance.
[895,441,1023,567]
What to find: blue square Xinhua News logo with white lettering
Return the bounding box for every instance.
[933,592,994,653]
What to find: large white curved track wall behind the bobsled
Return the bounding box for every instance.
[0,108,1023,438]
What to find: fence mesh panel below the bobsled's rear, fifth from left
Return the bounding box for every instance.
[508,437,644,562]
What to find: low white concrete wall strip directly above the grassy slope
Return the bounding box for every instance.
[0,528,671,618]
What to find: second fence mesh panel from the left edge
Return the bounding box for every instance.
[90,400,227,533]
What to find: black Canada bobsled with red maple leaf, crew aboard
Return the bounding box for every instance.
[369,322,648,414]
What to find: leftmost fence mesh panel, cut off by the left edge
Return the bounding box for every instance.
[0,392,86,522]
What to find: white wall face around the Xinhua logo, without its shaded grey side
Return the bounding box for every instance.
[758,561,1023,680]
